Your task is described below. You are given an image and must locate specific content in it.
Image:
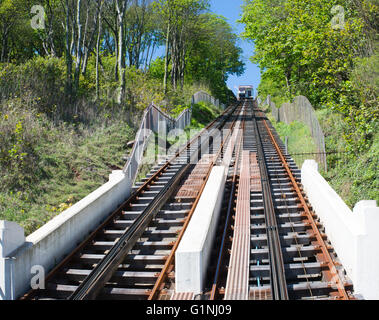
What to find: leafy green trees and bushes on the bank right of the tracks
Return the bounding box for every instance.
[241,0,379,206]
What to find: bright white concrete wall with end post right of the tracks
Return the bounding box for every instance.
[301,160,379,300]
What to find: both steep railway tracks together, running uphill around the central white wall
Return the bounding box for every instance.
[22,99,354,300]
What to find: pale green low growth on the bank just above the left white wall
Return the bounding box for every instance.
[0,115,134,234]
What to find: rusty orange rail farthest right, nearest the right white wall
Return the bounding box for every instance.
[263,120,350,300]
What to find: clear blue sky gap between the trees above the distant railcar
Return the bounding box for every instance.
[210,0,261,93]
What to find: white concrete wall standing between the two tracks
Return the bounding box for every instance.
[175,166,226,294]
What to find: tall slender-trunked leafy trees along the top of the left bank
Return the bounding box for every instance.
[0,0,244,103]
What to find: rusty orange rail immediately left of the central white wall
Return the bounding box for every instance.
[148,100,243,300]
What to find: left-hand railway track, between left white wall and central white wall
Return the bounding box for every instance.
[22,99,241,300]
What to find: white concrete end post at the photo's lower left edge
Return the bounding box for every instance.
[0,220,25,300]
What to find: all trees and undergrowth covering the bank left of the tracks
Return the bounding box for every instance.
[0,0,244,234]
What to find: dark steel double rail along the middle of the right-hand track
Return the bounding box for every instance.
[253,111,288,300]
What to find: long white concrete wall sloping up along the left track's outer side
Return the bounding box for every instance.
[0,171,131,300]
